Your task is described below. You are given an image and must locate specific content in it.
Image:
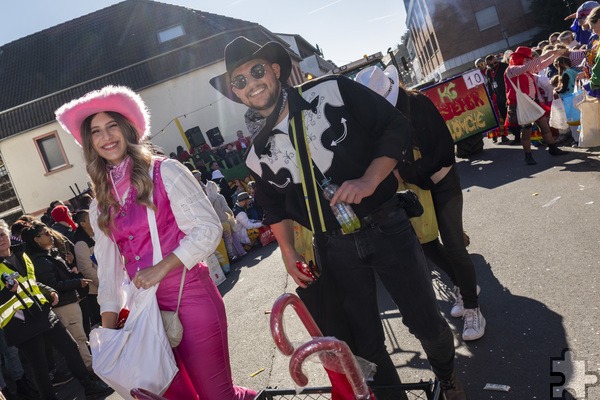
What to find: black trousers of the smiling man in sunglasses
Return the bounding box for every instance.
[315,208,454,385]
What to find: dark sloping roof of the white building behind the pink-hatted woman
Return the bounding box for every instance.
[0,0,287,139]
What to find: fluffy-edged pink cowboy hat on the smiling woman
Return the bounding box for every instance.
[54,86,150,145]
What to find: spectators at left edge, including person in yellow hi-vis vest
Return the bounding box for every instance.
[0,205,113,399]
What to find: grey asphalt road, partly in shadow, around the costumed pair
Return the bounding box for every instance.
[61,139,600,400]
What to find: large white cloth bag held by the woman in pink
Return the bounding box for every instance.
[90,283,179,400]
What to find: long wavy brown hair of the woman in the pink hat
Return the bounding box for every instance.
[81,111,156,235]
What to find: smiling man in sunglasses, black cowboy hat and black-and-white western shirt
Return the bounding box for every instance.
[210,37,466,400]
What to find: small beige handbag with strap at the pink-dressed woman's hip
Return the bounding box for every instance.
[146,207,187,347]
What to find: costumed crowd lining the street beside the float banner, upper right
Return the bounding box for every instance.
[475,1,600,161]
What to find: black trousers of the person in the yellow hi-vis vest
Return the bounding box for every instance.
[17,322,88,400]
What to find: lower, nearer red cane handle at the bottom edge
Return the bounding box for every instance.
[289,337,371,400]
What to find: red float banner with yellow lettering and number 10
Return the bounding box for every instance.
[422,70,498,143]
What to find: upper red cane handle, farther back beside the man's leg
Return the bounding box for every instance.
[270,293,323,356]
